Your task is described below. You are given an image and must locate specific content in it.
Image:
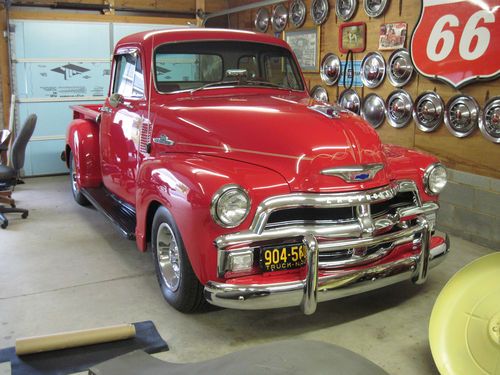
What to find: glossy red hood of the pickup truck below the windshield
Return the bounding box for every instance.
[153,89,389,192]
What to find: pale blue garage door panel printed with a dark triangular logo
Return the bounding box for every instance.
[16,62,110,98]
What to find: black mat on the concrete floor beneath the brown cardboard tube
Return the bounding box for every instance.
[0,321,168,375]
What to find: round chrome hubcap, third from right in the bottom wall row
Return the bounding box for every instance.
[413,91,444,133]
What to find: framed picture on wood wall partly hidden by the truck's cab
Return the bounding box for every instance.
[283,27,320,72]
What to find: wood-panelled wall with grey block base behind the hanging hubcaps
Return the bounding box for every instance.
[223,0,500,249]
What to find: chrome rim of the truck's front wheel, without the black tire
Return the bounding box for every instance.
[156,223,181,292]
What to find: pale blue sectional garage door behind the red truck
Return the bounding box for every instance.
[10,20,184,176]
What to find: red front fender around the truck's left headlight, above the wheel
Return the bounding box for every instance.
[136,153,290,284]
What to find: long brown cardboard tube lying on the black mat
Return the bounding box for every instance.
[16,324,135,355]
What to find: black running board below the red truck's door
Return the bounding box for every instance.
[81,187,136,240]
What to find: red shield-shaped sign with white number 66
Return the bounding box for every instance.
[410,0,500,88]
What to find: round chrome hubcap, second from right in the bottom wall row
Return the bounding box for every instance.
[444,95,479,138]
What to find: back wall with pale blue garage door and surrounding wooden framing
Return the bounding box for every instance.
[0,0,225,176]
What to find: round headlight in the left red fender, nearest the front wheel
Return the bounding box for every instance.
[210,185,250,228]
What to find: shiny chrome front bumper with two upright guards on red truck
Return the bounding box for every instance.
[205,225,450,315]
